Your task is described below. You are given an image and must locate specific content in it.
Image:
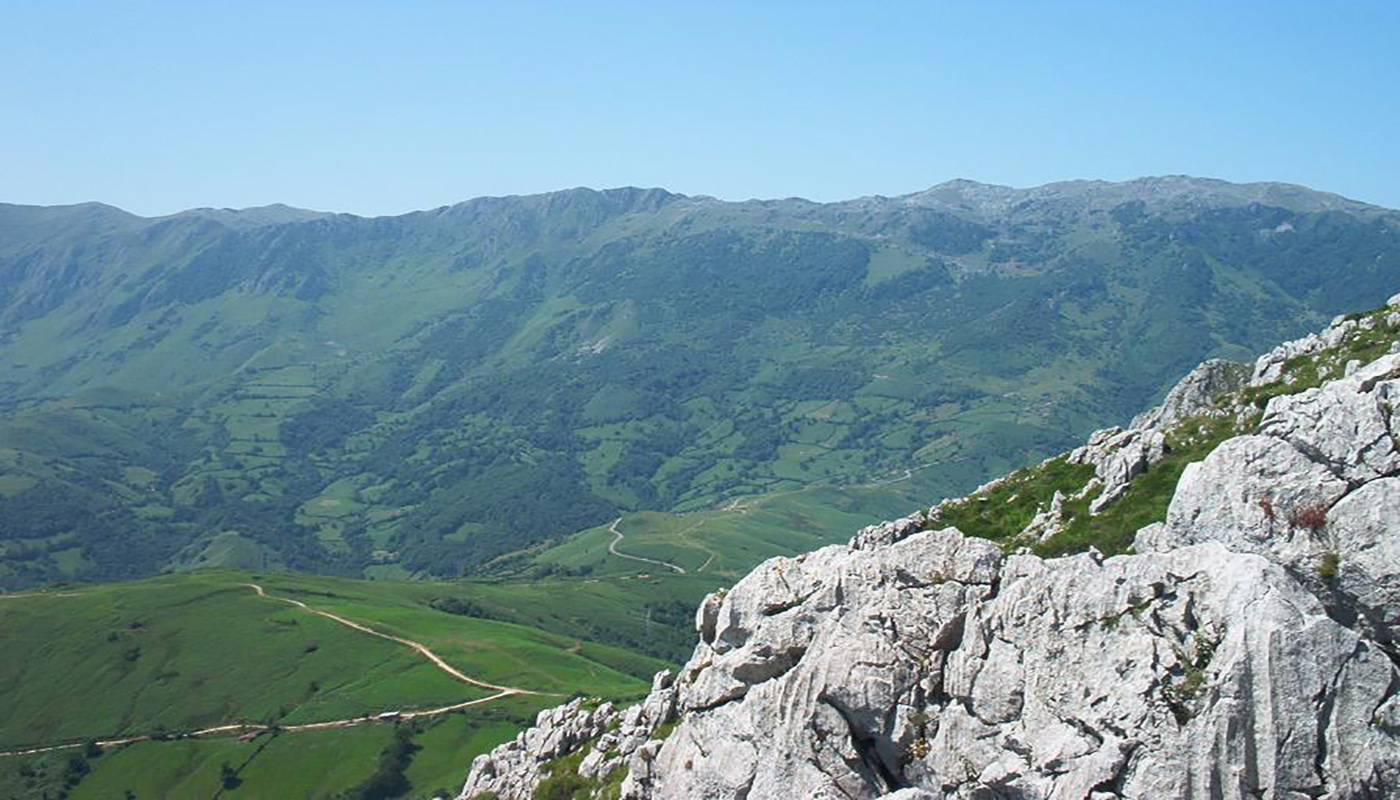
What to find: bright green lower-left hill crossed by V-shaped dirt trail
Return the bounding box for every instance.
[0,572,662,797]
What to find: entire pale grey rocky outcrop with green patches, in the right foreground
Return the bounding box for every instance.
[461,296,1400,800]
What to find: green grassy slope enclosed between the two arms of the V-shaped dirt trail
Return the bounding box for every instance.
[0,574,484,747]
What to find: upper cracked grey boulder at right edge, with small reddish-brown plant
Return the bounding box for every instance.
[1135,354,1400,644]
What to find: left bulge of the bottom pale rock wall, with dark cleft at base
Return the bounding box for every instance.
[646,530,1001,797]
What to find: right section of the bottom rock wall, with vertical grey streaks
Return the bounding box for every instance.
[929,544,1400,797]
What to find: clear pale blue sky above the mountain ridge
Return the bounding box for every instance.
[0,0,1400,214]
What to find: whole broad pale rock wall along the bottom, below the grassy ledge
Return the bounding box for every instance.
[624,530,1400,799]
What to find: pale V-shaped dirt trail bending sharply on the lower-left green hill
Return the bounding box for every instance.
[0,582,554,758]
